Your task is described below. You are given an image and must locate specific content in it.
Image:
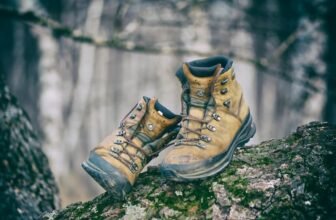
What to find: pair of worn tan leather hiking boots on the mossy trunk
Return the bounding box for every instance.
[82,56,256,199]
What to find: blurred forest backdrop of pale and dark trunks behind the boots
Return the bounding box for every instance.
[0,0,336,206]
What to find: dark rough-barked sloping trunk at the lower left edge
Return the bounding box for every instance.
[0,79,59,220]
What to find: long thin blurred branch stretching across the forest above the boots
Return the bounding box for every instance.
[0,5,324,92]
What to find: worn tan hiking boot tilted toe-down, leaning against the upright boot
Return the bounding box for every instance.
[82,97,181,199]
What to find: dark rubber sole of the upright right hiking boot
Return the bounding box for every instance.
[160,114,256,182]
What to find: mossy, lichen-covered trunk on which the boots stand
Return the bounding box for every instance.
[44,122,336,220]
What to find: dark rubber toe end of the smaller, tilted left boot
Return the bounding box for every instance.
[82,153,132,201]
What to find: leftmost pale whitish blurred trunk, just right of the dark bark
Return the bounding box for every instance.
[34,29,64,176]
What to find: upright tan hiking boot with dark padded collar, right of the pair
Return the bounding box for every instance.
[160,56,256,181]
